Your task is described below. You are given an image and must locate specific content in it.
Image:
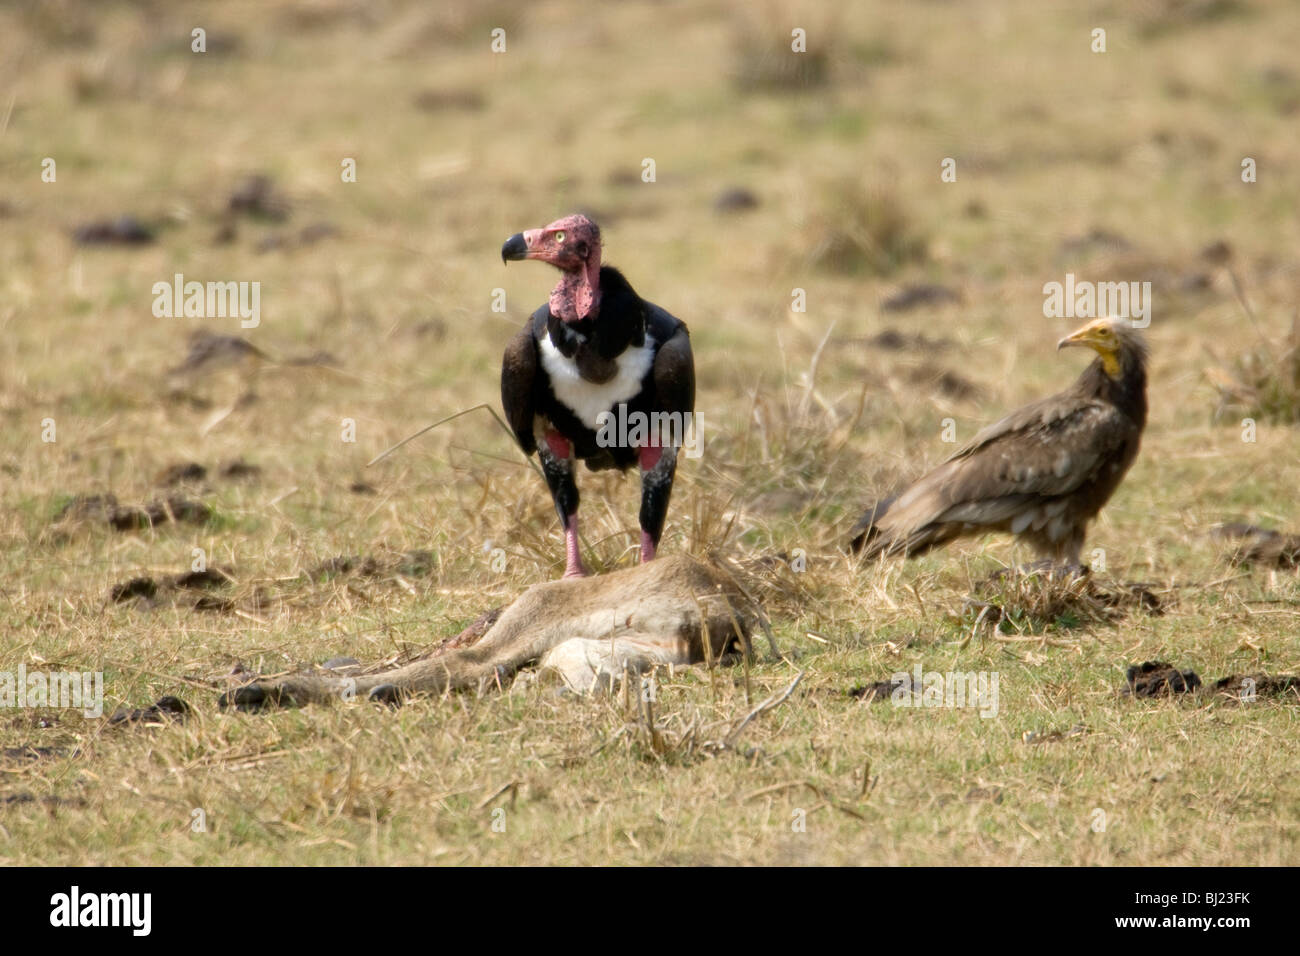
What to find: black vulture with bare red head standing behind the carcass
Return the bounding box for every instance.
[501,216,696,578]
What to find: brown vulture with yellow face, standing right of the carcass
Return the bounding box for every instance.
[850,319,1147,566]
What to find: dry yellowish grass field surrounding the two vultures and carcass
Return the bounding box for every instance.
[0,0,1300,865]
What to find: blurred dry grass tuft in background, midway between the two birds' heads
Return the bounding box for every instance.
[803,179,928,276]
